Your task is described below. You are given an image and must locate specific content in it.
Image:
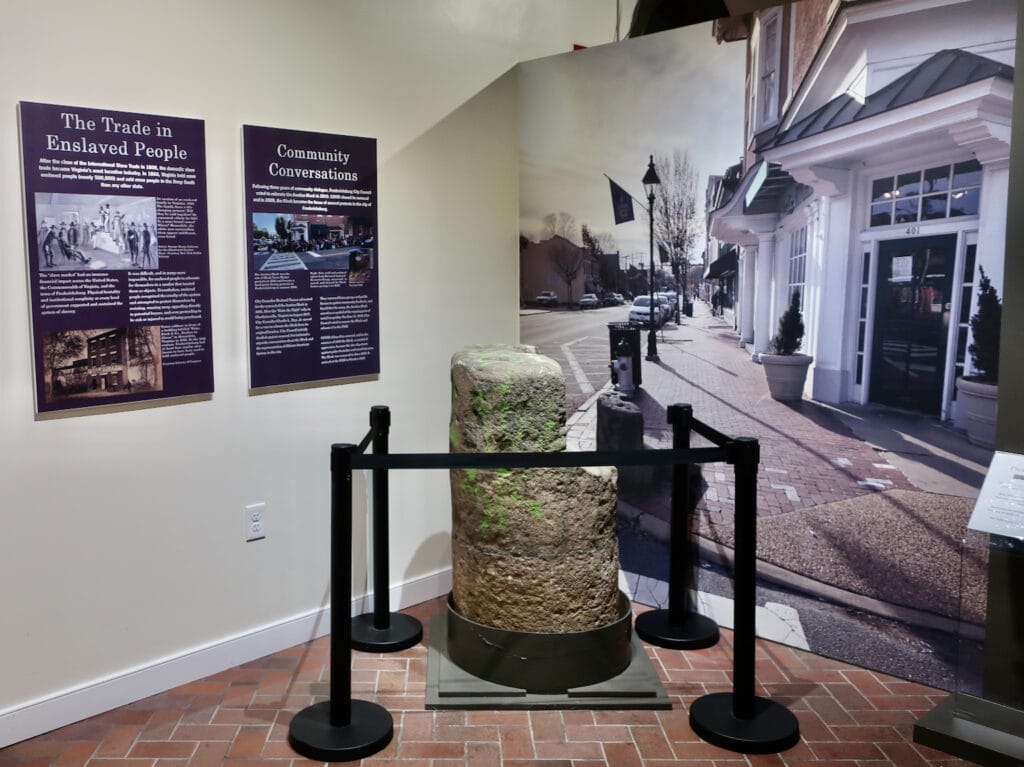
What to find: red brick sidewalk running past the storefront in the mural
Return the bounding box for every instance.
[614,310,913,532]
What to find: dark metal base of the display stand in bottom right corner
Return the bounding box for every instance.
[913,693,1024,767]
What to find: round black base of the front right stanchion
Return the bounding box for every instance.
[690,692,800,754]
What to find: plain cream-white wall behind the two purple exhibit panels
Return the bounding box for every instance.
[0,0,632,745]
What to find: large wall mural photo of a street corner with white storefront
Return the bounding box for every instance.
[519,0,1017,689]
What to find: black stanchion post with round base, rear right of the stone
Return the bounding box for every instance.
[635,404,719,650]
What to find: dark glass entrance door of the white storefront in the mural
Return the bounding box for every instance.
[868,235,956,414]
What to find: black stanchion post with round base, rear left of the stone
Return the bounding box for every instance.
[352,404,423,652]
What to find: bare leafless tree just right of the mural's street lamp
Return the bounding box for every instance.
[654,151,703,291]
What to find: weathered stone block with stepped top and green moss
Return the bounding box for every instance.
[451,346,618,633]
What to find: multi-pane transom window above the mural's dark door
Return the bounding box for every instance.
[870,160,981,226]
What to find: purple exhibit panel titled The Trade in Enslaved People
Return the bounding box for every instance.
[19,101,213,414]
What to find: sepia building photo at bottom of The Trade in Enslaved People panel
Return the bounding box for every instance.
[43,325,164,404]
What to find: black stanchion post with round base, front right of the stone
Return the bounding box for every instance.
[690,438,800,754]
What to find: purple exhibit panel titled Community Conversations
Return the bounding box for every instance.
[243,125,380,390]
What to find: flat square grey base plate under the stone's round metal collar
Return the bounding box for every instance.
[426,614,672,710]
